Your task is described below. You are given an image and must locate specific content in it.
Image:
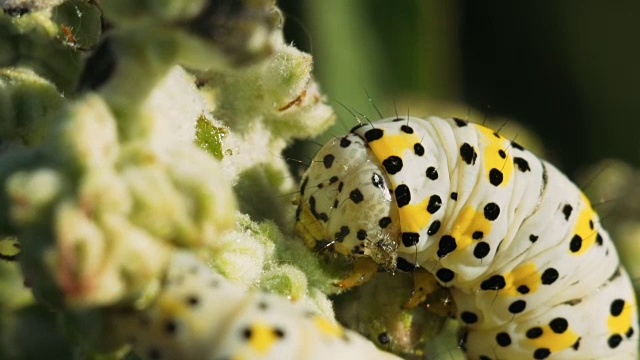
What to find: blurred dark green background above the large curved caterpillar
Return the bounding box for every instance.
[278,0,640,176]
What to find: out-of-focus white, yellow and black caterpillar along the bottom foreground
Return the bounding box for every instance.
[109,252,399,360]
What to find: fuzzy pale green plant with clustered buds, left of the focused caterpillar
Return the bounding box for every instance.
[0,0,450,359]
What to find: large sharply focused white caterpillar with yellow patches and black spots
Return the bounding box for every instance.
[296,116,638,360]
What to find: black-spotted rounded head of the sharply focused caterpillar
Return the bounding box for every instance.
[296,134,400,270]
